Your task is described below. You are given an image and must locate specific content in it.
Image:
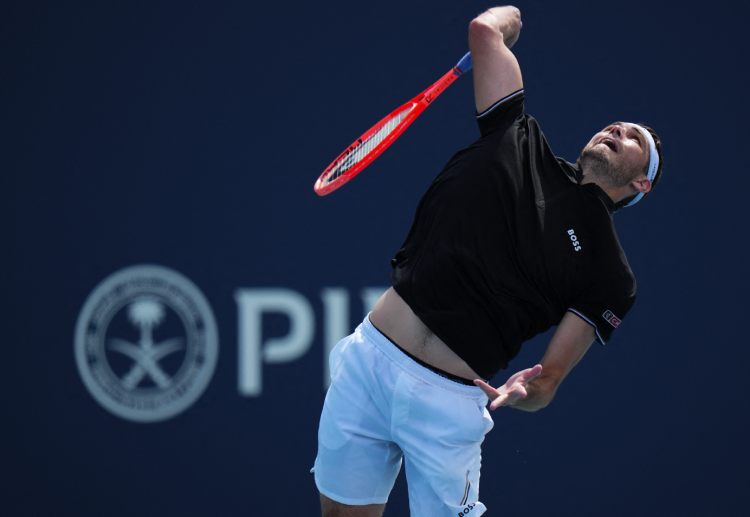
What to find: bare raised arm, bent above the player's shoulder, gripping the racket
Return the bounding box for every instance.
[469,6,523,113]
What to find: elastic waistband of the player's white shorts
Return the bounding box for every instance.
[357,314,486,400]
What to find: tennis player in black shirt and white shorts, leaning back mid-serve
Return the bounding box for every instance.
[313,6,661,517]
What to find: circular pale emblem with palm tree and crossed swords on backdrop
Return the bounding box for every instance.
[74,265,219,422]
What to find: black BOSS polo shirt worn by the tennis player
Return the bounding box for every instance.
[392,90,635,378]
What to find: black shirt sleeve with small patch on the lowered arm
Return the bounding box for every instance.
[568,271,635,345]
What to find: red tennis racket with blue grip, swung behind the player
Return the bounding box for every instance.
[314,52,471,196]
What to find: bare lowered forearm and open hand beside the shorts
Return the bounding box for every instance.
[474,312,596,411]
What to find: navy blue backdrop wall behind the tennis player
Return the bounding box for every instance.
[7,0,750,516]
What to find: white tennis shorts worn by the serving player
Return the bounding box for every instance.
[313,317,493,517]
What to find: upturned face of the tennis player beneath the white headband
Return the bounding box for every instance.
[582,122,649,184]
